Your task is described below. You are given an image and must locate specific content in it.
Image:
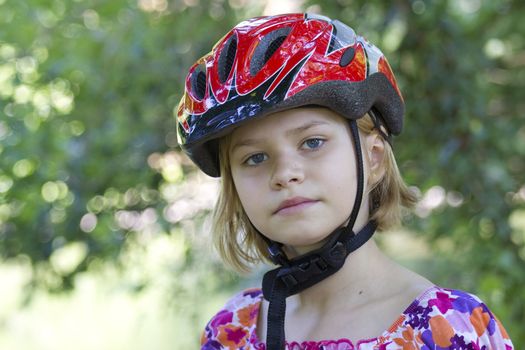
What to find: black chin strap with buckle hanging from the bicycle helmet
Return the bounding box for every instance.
[261,120,377,350]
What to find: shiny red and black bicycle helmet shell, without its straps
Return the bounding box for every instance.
[177,14,404,177]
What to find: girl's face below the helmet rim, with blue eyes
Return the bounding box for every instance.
[229,108,368,253]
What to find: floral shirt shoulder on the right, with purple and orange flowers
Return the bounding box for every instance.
[380,286,513,350]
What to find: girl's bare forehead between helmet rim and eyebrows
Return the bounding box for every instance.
[231,107,346,144]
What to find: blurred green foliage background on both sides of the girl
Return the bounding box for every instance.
[0,0,525,349]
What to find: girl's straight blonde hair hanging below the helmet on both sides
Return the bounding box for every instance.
[212,110,417,272]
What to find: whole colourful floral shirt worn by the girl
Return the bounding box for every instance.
[201,286,514,350]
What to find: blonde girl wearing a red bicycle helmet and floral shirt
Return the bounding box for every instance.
[177,14,513,350]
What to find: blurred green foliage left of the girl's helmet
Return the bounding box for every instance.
[0,0,252,298]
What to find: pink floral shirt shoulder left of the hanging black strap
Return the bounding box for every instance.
[201,288,262,350]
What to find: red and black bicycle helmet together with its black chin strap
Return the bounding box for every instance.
[177,14,404,350]
